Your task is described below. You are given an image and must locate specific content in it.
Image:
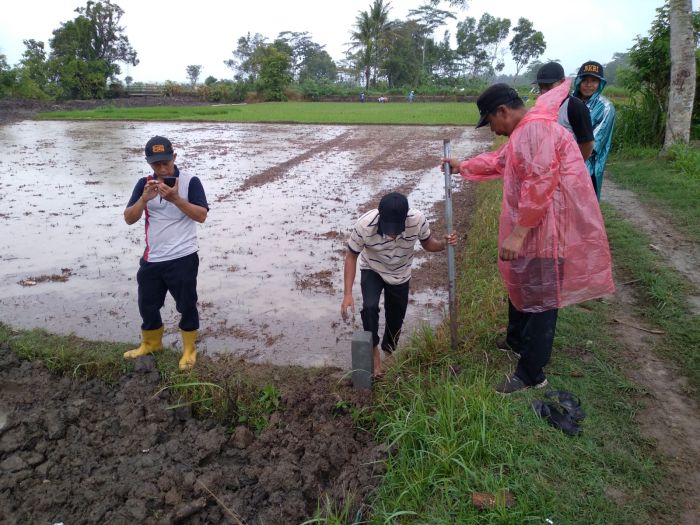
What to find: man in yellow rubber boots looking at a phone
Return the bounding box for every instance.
[124,136,209,370]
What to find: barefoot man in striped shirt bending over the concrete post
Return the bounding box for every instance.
[340,192,457,377]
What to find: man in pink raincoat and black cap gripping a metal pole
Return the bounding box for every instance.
[445,80,615,394]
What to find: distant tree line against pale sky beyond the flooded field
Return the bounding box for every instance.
[0,0,546,100]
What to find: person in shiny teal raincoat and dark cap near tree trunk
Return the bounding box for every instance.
[574,61,615,200]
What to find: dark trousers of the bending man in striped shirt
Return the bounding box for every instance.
[360,270,410,352]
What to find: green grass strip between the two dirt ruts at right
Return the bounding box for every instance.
[603,205,700,399]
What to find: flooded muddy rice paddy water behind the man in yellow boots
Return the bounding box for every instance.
[0,121,488,368]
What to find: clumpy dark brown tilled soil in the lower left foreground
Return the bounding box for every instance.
[0,345,385,524]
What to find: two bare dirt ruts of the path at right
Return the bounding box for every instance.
[603,181,700,525]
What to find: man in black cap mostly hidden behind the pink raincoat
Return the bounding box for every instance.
[536,62,593,160]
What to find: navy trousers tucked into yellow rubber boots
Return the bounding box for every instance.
[136,252,199,332]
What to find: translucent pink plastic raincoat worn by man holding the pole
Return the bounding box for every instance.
[460,80,615,312]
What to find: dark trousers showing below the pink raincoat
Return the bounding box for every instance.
[507,300,559,385]
